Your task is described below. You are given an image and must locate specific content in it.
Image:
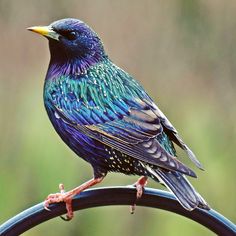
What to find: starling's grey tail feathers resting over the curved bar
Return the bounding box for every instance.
[146,166,210,211]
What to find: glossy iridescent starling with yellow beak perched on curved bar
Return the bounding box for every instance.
[28,18,210,220]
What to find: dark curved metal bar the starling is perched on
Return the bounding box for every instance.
[0,186,236,236]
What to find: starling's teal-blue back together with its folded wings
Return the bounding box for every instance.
[45,64,202,176]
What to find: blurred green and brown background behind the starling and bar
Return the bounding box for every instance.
[0,0,236,236]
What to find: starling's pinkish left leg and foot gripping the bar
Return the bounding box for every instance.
[44,177,104,221]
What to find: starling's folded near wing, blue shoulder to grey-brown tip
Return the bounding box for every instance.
[49,92,196,177]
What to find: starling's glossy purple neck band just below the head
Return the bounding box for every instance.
[46,51,108,79]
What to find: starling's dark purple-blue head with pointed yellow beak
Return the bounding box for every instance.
[28,18,106,72]
